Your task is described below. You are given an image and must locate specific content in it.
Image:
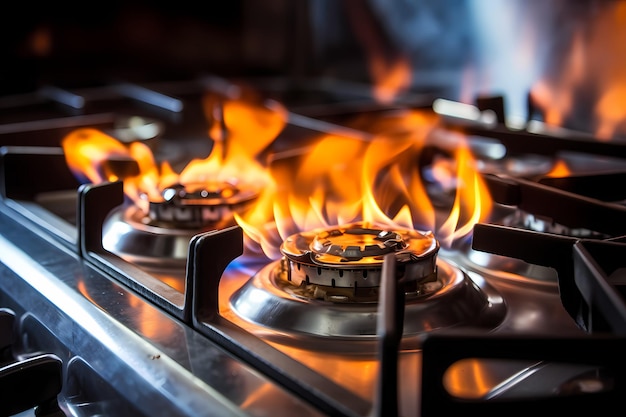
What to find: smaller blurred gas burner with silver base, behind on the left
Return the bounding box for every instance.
[102,182,258,268]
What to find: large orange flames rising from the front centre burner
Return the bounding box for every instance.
[235,112,491,259]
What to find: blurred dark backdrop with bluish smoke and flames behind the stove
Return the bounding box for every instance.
[0,0,626,137]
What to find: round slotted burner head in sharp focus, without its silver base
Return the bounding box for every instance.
[281,222,439,298]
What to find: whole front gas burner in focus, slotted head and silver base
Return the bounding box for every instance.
[230,223,505,349]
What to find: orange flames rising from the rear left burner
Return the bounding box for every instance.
[62,94,287,213]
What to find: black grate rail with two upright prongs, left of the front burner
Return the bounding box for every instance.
[46,148,378,416]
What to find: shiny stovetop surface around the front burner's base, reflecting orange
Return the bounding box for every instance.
[220,245,588,416]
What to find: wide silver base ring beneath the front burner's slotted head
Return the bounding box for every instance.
[230,255,506,340]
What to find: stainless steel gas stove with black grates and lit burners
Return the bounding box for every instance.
[0,72,626,417]
